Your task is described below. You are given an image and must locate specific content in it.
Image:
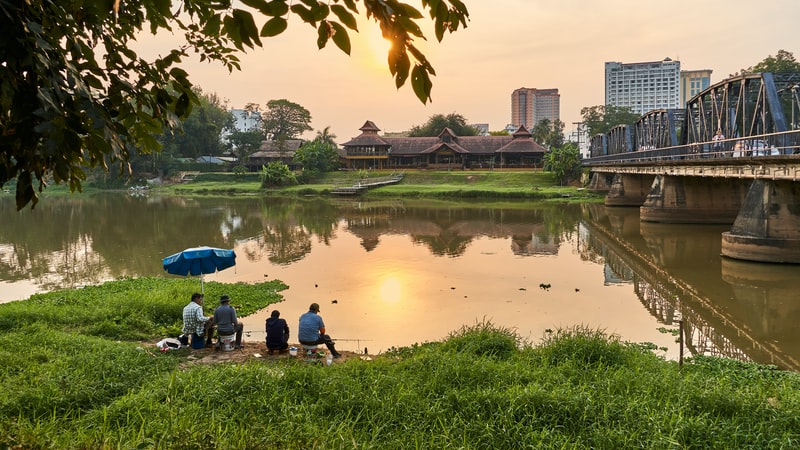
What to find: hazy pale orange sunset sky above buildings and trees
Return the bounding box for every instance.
[139,0,800,142]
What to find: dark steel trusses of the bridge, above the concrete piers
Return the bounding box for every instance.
[587,72,800,160]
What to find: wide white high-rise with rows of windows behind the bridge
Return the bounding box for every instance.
[605,58,683,114]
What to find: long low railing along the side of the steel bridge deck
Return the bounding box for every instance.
[583,130,800,166]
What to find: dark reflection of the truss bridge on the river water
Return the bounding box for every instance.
[580,205,800,371]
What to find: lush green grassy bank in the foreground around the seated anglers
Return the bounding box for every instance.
[0,278,800,449]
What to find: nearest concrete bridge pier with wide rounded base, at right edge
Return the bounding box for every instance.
[722,179,800,263]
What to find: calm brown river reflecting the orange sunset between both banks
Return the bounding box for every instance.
[0,194,800,370]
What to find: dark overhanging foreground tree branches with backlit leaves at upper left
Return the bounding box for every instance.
[0,0,469,209]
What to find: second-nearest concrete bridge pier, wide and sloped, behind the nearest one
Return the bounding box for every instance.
[639,175,750,224]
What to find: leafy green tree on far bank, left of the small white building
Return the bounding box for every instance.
[163,88,233,158]
